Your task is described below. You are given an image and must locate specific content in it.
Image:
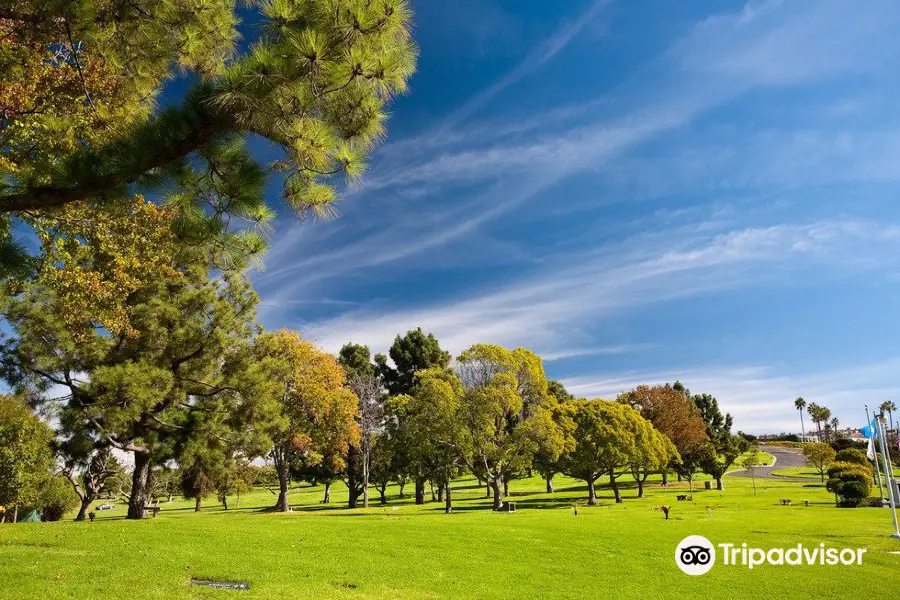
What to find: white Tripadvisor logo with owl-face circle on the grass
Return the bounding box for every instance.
[675,535,866,575]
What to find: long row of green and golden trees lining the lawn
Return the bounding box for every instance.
[0,251,746,519]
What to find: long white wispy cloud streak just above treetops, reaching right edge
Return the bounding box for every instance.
[301,221,900,358]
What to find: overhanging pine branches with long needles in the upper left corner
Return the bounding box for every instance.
[0,0,416,274]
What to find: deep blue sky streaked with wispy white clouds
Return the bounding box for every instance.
[253,0,900,432]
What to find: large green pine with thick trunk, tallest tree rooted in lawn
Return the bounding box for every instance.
[2,253,270,519]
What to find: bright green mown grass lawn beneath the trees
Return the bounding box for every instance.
[0,478,900,600]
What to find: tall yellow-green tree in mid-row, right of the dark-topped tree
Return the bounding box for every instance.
[457,344,565,510]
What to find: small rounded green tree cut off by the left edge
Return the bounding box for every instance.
[0,394,53,520]
